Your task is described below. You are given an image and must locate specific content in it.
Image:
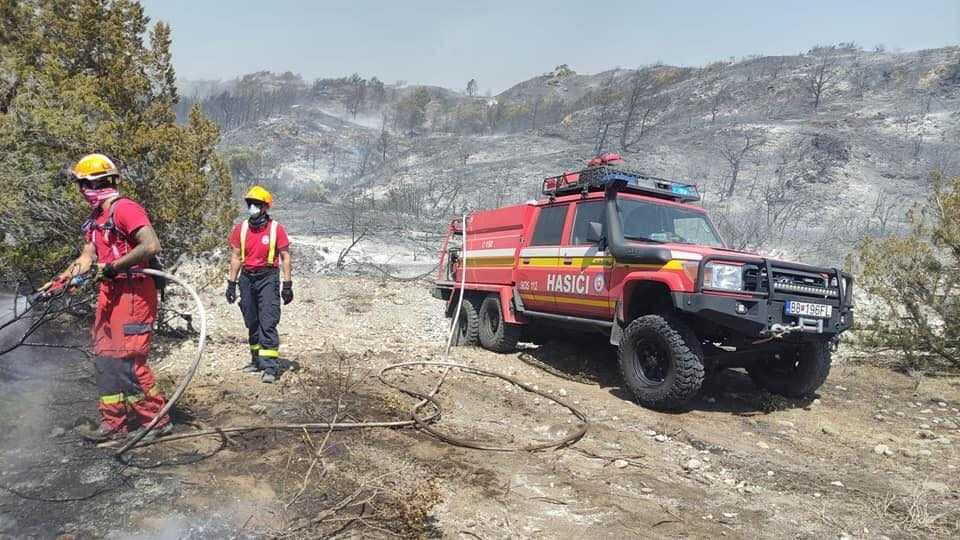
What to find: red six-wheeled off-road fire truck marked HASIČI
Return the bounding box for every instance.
[433,154,853,409]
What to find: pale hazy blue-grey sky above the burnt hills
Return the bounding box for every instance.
[143,0,960,93]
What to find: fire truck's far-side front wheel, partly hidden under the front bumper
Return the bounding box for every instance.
[747,341,832,398]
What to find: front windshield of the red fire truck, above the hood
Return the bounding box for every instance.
[617,197,724,247]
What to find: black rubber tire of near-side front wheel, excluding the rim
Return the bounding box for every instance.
[617,315,705,410]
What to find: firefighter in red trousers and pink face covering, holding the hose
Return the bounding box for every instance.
[44,154,173,442]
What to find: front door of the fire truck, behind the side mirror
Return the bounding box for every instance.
[554,200,613,320]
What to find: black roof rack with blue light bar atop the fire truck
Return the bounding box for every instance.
[543,165,700,202]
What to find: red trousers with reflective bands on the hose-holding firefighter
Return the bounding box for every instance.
[93,276,170,431]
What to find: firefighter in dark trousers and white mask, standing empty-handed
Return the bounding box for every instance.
[226,186,293,383]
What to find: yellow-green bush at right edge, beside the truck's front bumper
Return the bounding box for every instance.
[856,177,960,369]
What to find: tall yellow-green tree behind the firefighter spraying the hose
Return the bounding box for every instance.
[0,0,235,278]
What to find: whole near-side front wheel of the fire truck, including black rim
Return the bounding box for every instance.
[617,315,704,410]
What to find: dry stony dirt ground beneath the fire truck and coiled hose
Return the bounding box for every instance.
[0,278,960,538]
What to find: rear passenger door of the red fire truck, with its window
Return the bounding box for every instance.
[517,203,570,313]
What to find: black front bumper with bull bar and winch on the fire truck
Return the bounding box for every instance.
[672,257,853,339]
